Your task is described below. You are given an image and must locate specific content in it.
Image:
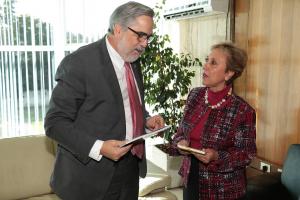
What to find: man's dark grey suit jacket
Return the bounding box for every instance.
[45,38,147,200]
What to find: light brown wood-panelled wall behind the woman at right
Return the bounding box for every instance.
[235,0,300,164]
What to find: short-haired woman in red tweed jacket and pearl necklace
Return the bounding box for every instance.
[171,43,256,200]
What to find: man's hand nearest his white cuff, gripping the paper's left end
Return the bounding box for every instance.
[100,140,132,161]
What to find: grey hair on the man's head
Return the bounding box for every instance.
[108,1,154,34]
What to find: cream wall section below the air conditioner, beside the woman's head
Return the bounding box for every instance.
[178,13,230,87]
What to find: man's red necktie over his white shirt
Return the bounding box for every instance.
[124,62,144,158]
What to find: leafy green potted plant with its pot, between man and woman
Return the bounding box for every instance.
[140,1,202,188]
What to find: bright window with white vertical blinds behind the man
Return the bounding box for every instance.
[0,0,158,138]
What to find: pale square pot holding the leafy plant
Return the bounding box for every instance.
[151,144,182,189]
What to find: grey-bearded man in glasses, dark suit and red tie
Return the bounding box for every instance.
[45,2,164,200]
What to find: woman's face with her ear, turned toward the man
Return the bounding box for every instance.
[202,49,234,92]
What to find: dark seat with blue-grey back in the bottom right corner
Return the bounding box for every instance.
[247,144,300,200]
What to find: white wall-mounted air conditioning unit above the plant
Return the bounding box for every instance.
[163,0,230,20]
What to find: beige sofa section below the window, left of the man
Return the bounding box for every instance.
[0,135,55,199]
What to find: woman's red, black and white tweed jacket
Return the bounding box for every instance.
[171,87,256,200]
